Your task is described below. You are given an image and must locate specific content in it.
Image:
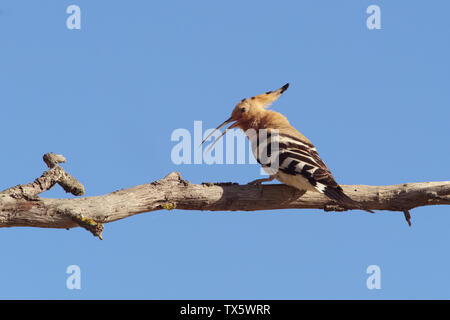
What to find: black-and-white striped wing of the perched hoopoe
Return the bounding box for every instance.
[251,131,368,207]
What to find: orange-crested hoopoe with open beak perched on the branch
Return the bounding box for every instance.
[202,83,373,212]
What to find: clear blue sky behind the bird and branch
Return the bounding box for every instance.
[0,0,450,299]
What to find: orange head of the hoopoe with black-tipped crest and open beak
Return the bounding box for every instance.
[202,83,289,147]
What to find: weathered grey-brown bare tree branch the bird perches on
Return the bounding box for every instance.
[0,153,450,238]
